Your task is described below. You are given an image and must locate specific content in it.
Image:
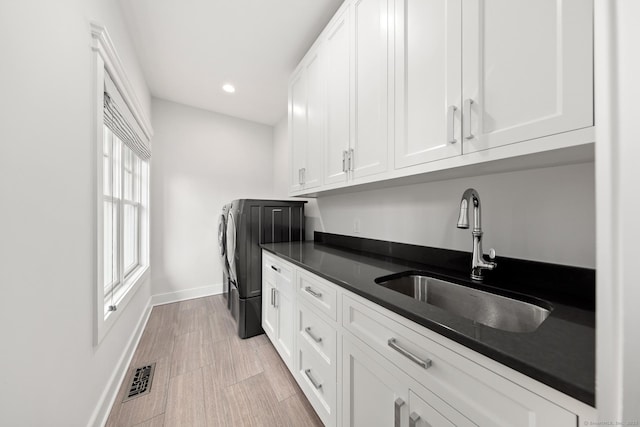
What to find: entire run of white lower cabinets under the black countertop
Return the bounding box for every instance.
[262,253,596,427]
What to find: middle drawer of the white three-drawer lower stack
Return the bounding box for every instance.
[298,303,336,365]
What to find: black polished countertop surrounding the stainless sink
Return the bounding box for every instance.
[262,239,595,406]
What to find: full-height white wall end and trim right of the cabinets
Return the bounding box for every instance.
[595,0,640,425]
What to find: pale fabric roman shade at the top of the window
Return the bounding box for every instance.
[104,72,151,160]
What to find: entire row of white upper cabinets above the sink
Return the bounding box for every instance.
[289,0,594,195]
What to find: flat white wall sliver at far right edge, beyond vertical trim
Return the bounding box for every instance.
[612,0,640,423]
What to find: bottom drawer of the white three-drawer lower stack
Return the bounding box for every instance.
[297,340,336,426]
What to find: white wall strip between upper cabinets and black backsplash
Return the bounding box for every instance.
[317,163,595,268]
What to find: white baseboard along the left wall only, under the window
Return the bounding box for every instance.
[88,298,152,427]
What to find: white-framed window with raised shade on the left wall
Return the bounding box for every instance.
[91,23,152,345]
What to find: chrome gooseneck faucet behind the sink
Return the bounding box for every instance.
[458,188,498,280]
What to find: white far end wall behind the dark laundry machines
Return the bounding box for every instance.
[151,98,274,294]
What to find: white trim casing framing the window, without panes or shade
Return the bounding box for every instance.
[91,23,153,345]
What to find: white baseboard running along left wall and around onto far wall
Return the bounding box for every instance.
[88,283,223,427]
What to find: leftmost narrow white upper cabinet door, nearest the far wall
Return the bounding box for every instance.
[289,68,307,191]
